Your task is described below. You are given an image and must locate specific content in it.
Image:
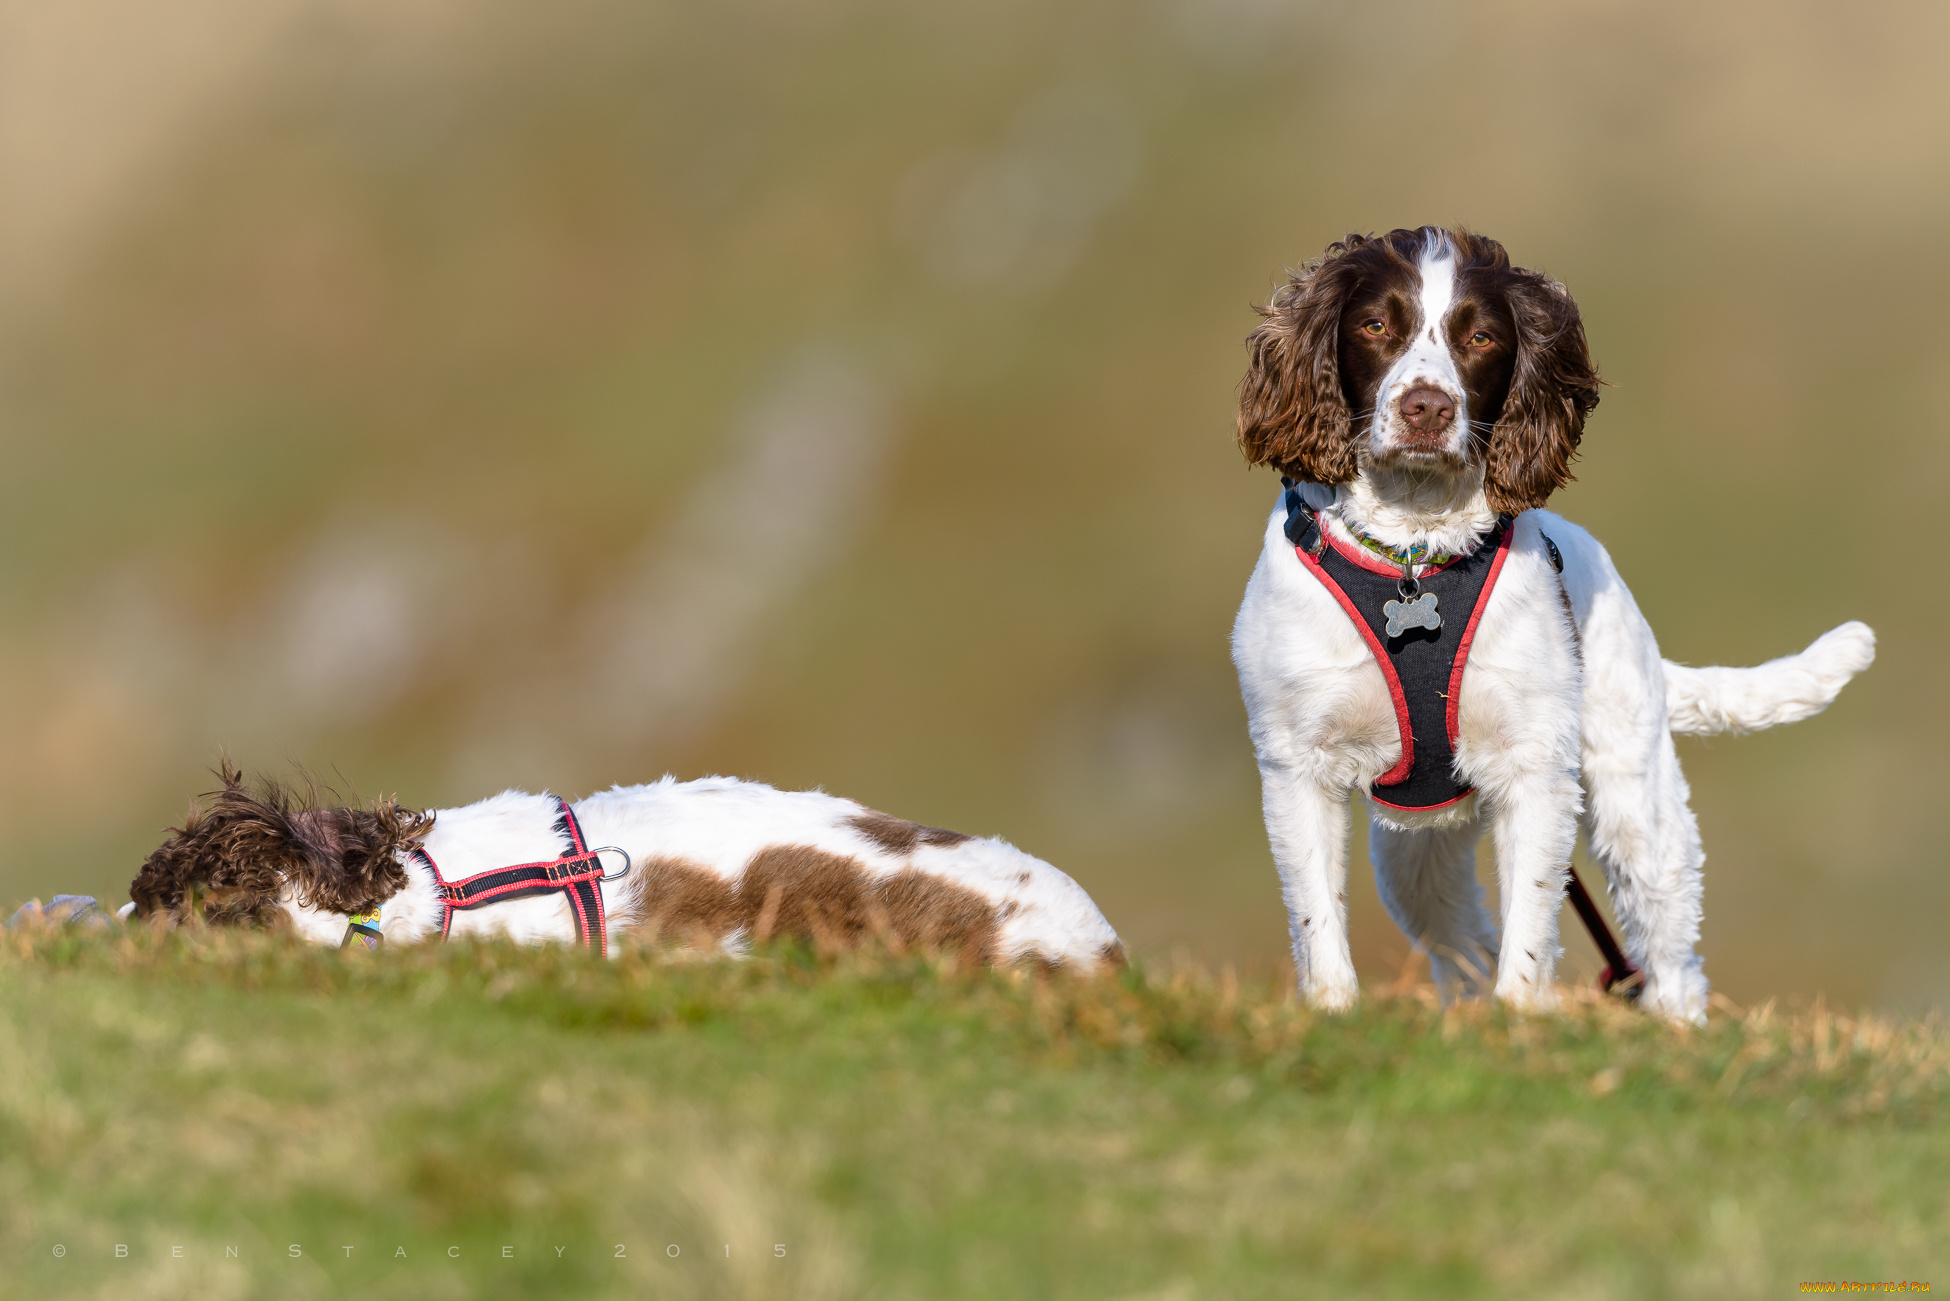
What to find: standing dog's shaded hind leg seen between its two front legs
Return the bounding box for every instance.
[1367,815,1496,1003]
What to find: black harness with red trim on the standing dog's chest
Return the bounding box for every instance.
[1287,488,1511,809]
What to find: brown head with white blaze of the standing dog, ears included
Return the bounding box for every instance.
[1238,226,1599,513]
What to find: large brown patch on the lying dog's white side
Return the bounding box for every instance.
[636,838,998,962]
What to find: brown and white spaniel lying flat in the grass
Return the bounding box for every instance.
[129,763,1123,967]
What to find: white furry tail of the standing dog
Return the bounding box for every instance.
[1665,622,1876,735]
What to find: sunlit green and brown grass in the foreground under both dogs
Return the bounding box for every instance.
[0,930,1950,1301]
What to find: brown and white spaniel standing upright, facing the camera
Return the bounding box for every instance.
[1232,228,1874,1020]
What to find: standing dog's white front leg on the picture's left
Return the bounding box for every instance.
[1260,767,1361,1010]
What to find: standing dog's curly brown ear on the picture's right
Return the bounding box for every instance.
[1484,271,1599,515]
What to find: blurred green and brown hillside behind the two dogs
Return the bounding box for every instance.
[0,0,1950,1008]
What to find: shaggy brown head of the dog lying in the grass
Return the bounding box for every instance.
[129,761,433,925]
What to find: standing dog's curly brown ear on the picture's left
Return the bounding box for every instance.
[1238,234,1369,484]
